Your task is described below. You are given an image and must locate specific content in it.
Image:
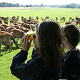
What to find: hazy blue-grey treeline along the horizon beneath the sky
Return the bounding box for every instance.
[0,2,80,8]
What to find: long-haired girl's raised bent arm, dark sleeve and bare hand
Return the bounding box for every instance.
[10,34,35,80]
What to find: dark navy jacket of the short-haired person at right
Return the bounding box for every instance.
[60,50,80,80]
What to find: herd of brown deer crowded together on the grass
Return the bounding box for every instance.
[0,16,80,53]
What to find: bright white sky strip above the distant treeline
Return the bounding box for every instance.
[0,0,80,5]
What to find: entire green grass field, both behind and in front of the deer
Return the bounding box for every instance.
[0,8,80,80]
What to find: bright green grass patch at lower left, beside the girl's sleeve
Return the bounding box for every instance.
[0,49,20,80]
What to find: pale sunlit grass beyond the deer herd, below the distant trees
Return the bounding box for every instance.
[0,8,80,25]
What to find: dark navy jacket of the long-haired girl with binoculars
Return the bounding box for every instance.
[10,50,59,80]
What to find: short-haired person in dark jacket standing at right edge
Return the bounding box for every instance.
[61,24,80,80]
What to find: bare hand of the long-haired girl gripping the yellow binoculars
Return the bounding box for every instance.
[21,34,32,52]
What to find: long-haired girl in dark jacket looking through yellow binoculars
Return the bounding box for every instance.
[11,21,62,80]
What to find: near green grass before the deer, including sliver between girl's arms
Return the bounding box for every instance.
[0,41,33,80]
